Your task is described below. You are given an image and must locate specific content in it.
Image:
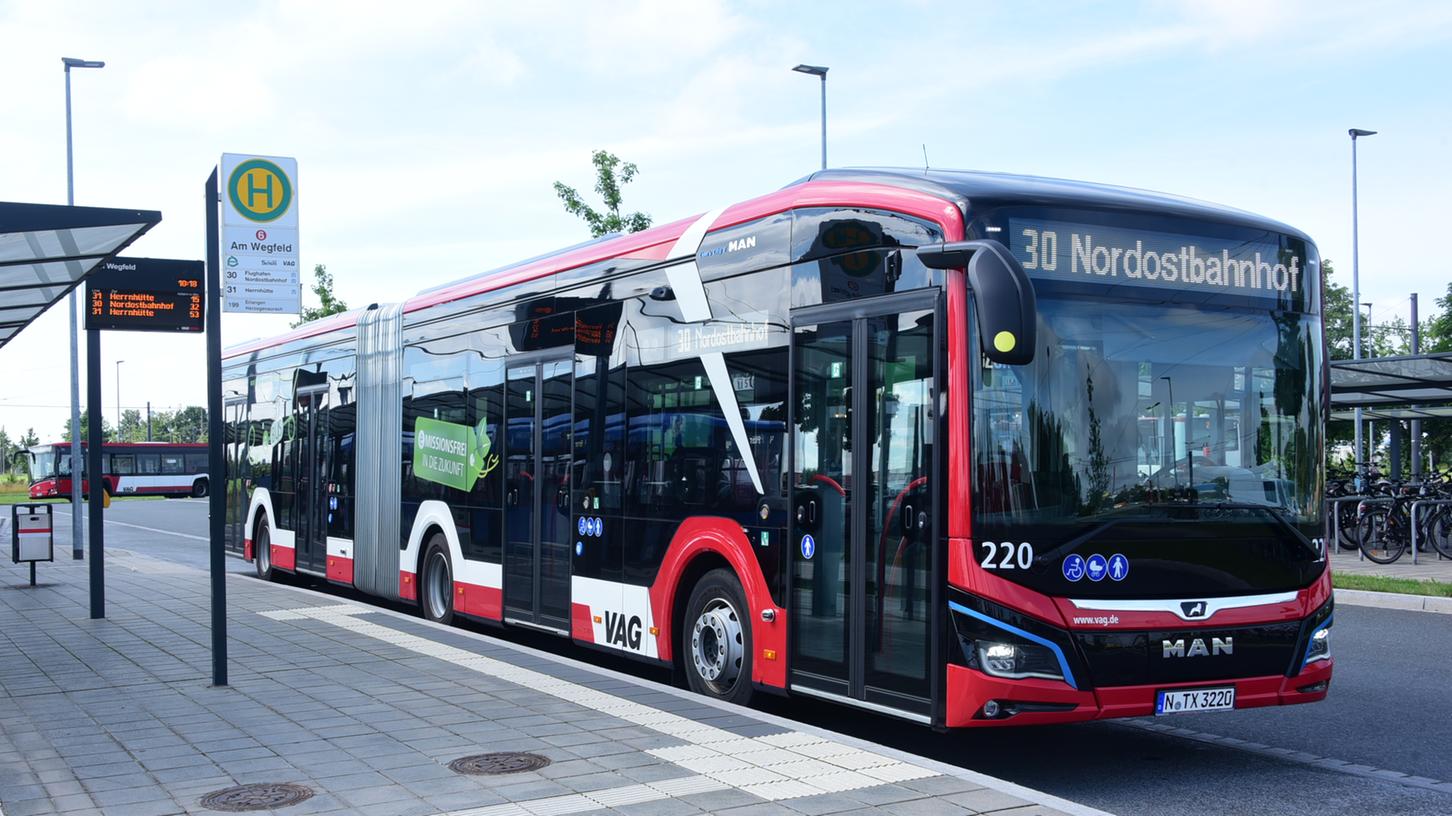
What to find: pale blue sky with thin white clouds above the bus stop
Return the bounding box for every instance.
[0,0,1452,437]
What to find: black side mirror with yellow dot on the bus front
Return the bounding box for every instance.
[918,241,1038,366]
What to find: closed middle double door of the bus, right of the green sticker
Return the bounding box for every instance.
[504,359,575,635]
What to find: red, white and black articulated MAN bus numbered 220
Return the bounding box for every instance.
[224,170,1331,727]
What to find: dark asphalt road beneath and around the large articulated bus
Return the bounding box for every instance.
[42,499,1452,816]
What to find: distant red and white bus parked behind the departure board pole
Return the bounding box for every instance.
[28,441,208,498]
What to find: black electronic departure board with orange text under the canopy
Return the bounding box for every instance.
[86,257,206,331]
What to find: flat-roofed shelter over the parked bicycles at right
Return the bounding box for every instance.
[1329,353,1452,478]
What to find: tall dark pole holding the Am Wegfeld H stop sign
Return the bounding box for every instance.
[206,168,227,685]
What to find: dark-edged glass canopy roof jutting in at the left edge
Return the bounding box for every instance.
[0,202,161,348]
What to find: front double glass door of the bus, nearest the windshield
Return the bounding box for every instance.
[788,295,941,720]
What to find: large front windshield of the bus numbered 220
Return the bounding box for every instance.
[973,296,1324,577]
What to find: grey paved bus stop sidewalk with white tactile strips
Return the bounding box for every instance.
[0,542,1099,816]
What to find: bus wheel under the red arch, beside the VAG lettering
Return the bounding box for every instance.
[681,569,752,706]
